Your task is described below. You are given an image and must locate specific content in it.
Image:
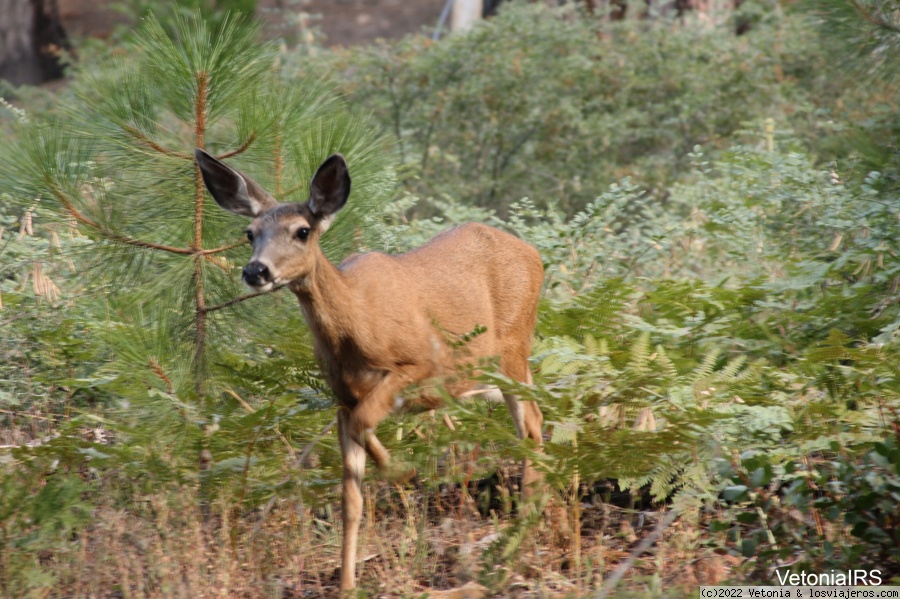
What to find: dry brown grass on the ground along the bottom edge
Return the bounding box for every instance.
[19,482,735,599]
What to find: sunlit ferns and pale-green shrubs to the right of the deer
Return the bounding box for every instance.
[370,130,900,568]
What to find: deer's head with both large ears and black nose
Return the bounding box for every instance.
[194,148,350,291]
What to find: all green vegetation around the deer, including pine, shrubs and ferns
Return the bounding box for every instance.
[0,2,900,595]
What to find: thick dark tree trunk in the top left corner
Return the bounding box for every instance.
[0,0,70,85]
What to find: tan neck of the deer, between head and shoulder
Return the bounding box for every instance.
[289,248,360,355]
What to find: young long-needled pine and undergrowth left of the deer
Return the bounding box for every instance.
[0,14,394,594]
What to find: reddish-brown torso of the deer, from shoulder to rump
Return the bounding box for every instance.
[341,223,543,364]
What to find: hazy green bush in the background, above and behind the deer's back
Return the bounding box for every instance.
[336,3,819,216]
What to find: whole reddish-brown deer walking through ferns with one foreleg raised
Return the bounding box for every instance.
[195,148,543,592]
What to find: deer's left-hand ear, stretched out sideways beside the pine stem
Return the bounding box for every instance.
[194,148,278,218]
